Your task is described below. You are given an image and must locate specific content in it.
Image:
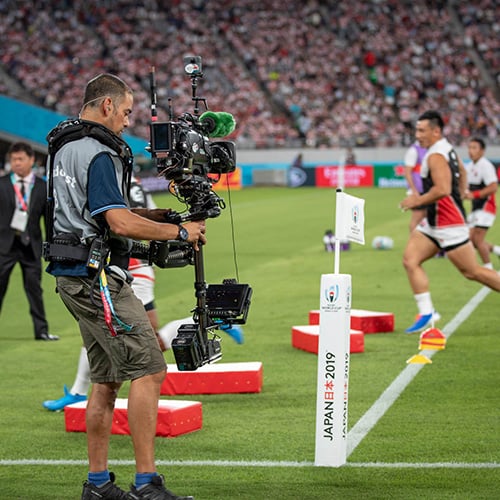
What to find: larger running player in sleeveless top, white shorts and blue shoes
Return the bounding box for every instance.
[400,110,500,333]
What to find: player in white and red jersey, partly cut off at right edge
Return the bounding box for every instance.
[465,137,500,269]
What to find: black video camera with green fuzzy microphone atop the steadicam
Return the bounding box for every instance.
[148,56,236,225]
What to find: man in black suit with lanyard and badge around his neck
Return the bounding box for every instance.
[0,142,59,340]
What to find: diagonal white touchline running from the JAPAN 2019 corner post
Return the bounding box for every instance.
[347,287,491,457]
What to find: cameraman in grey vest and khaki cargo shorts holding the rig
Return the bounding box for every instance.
[47,74,202,500]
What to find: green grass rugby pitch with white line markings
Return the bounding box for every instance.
[0,188,500,500]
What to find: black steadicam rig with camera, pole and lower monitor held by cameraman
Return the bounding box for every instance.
[144,56,252,371]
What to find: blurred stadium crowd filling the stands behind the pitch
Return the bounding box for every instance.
[0,0,500,148]
